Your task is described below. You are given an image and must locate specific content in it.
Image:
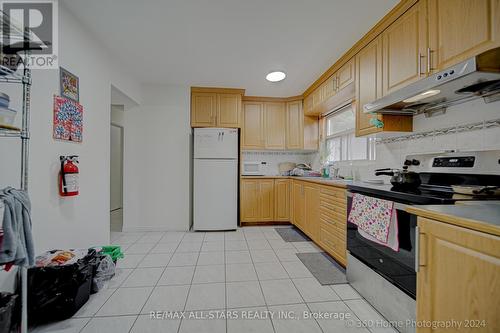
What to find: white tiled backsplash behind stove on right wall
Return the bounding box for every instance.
[314,99,500,182]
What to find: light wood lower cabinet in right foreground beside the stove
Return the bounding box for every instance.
[417,218,500,333]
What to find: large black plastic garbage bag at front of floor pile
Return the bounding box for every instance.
[28,249,96,325]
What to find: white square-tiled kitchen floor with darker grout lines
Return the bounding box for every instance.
[33,227,395,333]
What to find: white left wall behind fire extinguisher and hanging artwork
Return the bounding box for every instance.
[0,2,140,260]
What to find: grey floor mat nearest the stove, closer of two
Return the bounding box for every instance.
[297,252,347,285]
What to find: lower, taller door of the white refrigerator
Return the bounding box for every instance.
[193,159,238,230]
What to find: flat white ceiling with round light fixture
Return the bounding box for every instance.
[63,0,398,97]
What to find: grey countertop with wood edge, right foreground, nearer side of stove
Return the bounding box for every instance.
[406,201,500,236]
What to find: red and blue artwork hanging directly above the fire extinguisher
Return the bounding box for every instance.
[54,96,83,142]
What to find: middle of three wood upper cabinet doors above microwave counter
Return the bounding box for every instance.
[264,102,286,149]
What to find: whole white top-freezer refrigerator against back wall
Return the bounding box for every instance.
[193,128,239,231]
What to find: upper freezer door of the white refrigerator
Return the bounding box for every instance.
[194,128,238,159]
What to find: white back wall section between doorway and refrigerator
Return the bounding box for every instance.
[123,86,191,231]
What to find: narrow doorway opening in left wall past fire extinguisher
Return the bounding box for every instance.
[110,105,124,231]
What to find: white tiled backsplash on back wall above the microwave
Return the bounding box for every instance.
[241,150,316,176]
